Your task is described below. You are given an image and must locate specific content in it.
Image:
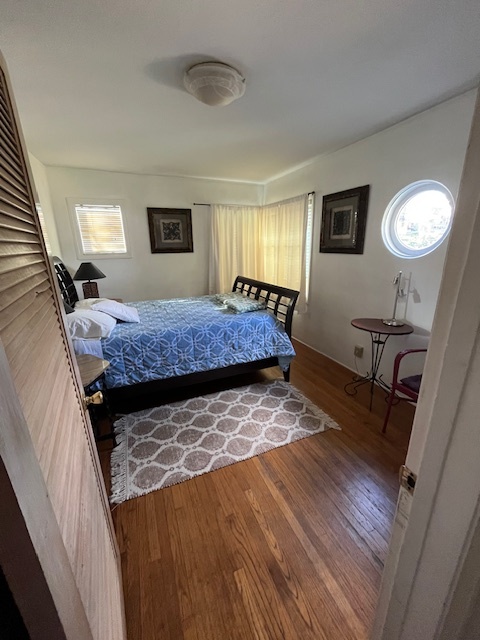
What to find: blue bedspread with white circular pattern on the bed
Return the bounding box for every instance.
[102,296,295,389]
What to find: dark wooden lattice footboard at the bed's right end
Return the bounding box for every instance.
[232,276,300,337]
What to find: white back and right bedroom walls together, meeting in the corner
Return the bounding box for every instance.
[42,91,475,379]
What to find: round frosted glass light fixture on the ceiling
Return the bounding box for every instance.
[183,62,245,107]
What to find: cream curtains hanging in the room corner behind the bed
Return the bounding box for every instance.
[209,195,308,311]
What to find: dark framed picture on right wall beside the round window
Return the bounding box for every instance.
[320,184,370,253]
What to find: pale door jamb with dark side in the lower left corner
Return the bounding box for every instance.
[0,341,92,640]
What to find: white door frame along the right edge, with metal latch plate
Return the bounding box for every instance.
[372,87,480,640]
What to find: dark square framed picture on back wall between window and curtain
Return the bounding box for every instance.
[147,207,193,253]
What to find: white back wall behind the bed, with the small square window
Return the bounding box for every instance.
[47,167,263,301]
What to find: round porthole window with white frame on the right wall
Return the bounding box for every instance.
[382,180,454,258]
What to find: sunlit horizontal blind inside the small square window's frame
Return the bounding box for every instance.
[75,204,127,255]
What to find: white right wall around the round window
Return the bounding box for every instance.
[265,91,475,380]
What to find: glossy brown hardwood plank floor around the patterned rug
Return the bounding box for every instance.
[101,343,413,640]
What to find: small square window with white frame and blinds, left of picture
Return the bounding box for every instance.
[68,198,130,258]
